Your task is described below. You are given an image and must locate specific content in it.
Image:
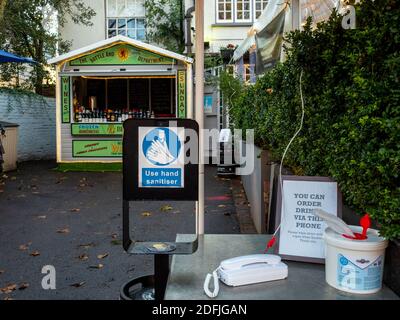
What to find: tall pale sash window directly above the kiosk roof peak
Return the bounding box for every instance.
[107,0,146,40]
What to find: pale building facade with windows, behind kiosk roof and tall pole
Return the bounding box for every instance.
[60,0,268,53]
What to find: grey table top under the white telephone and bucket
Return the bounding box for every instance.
[165,234,399,300]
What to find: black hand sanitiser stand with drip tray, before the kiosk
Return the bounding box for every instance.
[121,119,198,300]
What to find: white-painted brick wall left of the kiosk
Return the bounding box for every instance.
[0,90,56,161]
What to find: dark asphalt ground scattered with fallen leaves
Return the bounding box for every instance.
[0,161,240,299]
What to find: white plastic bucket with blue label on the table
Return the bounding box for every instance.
[324,226,388,294]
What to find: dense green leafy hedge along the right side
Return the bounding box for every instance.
[221,0,400,239]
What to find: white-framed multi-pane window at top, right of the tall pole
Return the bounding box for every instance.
[216,0,268,23]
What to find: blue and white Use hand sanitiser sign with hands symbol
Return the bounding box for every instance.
[138,127,185,188]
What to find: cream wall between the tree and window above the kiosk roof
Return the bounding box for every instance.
[60,0,106,51]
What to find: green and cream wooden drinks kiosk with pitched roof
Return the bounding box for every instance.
[48,36,193,168]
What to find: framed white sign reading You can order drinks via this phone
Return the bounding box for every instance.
[278,176,341,262]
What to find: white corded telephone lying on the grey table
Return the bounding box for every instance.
[204,254,288,298]
